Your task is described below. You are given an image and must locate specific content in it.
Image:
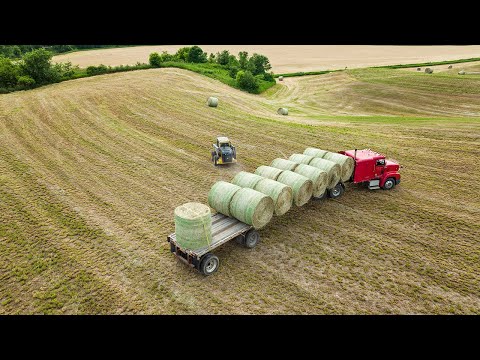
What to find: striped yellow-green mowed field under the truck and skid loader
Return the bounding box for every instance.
[0,69,480,314]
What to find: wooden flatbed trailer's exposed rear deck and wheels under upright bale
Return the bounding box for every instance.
[167,213,260,275]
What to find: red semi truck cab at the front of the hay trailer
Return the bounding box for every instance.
[340,149,400,190]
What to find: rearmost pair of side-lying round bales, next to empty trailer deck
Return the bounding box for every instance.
[208,181,274,229]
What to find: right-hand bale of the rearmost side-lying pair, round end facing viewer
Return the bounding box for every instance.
[230,188,274,229]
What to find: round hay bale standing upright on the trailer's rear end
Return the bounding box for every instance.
[174,202,212,250]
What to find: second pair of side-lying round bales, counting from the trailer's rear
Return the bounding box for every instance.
[232,171,293,216]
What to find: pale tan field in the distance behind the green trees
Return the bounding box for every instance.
[54,45,480,74]
